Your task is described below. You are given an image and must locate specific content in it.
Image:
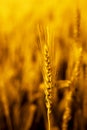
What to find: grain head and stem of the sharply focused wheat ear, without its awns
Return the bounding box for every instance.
[44,45,52,130]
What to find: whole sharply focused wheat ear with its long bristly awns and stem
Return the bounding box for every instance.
[39,25,52,130]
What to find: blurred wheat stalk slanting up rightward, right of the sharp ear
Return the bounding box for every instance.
[62,48,82,130]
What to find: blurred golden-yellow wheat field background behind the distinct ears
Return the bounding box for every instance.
[0,0,87,130]
